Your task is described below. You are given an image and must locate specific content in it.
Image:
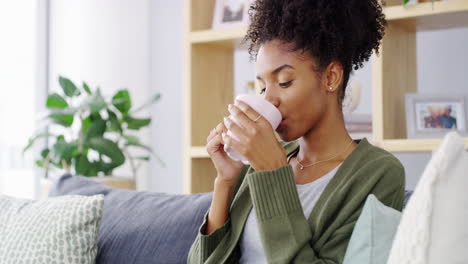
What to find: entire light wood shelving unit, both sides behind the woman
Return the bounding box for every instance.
[183,0,468,193]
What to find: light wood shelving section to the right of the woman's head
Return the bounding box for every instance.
[372,0,468,152]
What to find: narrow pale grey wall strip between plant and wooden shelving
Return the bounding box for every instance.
[150,0,185,193]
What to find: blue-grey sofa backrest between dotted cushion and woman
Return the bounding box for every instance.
[50,175,212,264]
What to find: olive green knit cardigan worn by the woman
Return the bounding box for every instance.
[188,138,405,264]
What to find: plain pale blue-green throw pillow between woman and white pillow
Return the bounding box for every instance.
[343,194,401,264]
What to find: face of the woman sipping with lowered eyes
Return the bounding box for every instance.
[255,40,329,141]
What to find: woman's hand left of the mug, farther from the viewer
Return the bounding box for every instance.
[206,118,244,185]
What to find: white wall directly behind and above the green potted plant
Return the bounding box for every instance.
[49,0,151,190]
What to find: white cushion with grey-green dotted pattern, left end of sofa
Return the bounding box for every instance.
[0,195,104,264]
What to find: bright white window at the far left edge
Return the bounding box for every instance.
[0,0,47,198]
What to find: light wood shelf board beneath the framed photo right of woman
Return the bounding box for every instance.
[379,138,468,152]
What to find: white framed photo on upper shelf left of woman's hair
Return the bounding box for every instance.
[212,0,253,29]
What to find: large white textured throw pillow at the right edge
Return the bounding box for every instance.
[387,132,468,264]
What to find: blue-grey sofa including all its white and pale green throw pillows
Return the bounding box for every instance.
[0,132,468,264]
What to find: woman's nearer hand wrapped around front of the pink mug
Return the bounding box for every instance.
[223,100,288,171]
